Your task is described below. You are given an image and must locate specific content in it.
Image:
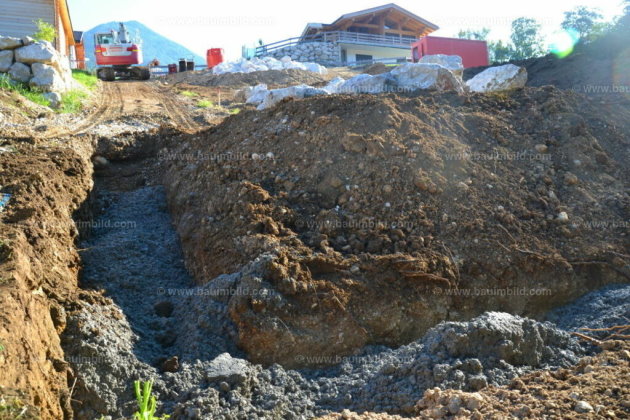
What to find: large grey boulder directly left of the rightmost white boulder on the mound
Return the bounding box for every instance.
[390,63,465,93]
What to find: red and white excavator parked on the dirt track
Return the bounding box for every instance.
[94,23,151,82]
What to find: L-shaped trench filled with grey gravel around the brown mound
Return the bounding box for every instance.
[56,127,630,419]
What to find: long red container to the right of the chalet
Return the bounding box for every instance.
[411,36,489,68]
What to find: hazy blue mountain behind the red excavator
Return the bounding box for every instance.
[83,20,206,67]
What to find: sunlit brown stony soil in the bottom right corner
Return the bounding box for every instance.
[320,341,630,420]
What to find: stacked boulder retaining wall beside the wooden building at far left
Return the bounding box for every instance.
[0,36,77,106]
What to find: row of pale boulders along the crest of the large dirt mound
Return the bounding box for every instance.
[236,55,527,110]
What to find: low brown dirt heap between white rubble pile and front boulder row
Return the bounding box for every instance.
[166,69,329,88]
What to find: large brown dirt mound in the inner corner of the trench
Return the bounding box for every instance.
[161,87,630,366]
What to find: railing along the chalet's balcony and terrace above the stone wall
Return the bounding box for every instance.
[255,31,416,57]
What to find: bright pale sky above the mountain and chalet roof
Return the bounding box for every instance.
[68,0,623,60]
